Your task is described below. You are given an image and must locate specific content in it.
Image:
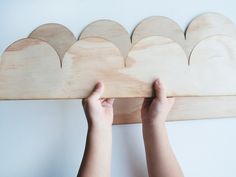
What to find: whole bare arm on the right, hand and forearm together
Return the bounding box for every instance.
[141,80,183,177]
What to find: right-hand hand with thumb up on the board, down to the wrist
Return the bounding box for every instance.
[141,79,174,124]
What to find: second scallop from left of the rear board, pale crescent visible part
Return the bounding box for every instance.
[80,20,131,57]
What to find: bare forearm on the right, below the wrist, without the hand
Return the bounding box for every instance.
[143,122,183,177]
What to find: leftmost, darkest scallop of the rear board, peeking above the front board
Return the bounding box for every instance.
[29,23,76,61]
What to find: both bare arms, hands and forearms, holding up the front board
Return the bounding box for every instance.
[78,80,183,177]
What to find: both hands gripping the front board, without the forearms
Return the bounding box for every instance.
[82,79,174,129]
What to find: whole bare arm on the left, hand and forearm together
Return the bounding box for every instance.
[77,83,114,177]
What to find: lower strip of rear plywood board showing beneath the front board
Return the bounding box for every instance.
[114,96,236,124]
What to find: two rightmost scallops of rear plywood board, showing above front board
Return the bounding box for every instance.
[132,13,236,57]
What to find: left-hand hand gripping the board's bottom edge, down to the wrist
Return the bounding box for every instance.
[82,82,114,129]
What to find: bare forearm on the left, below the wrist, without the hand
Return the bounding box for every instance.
[78,127,112,177]
